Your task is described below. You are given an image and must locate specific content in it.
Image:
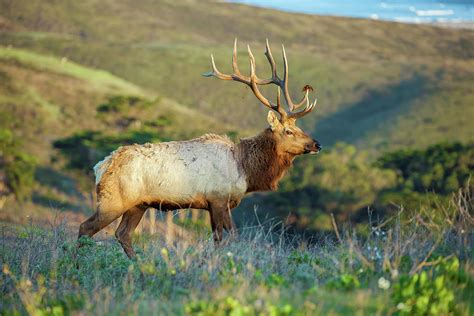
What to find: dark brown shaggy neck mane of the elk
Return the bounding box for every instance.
[237,129,294,192]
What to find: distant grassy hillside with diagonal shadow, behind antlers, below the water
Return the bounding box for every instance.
[0,0,474,152]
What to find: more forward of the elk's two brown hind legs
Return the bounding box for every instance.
[115,207,146,259]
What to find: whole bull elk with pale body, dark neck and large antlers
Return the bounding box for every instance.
[79,40,321,258]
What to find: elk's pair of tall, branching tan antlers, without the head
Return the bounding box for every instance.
[203,39,317,121]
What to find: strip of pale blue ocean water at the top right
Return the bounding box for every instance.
[230,0,474,23]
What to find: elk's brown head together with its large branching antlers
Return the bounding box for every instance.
[203,39,321,156]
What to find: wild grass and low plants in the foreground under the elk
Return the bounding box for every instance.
[0,192,474,315]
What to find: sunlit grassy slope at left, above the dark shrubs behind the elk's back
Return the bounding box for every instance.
[0,46,233,160]
